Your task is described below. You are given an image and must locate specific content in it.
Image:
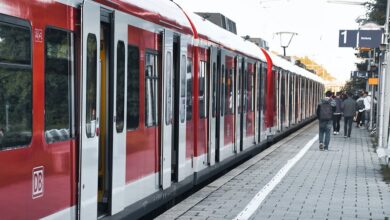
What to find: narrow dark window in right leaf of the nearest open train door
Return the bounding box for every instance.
[116,41,126,133]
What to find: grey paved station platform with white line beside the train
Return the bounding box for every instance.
[157,122,390,219]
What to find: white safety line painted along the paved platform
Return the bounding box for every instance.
[234,134,318,220]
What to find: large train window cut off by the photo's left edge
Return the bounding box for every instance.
[0,17,32,150]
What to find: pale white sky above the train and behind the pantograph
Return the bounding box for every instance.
[174,0,365,81]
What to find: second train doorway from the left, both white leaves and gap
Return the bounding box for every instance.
[160,30,187,189]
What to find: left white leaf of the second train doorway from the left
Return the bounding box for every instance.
[160,30,174,189]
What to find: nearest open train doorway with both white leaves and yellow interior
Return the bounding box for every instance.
[79,0,127,219]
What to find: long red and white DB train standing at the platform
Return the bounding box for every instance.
[0,0,324,219]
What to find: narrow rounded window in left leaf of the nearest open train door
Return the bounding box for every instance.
[85,33,97,138]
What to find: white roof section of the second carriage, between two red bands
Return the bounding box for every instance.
[187,12,266,62]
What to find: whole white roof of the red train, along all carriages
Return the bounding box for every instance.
[56,0,323,83]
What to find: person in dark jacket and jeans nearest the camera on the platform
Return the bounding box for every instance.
[316,91,336,150]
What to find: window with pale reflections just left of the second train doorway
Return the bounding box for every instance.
[145,52,158,127]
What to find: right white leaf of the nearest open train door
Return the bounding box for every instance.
[110,11,127,215]
